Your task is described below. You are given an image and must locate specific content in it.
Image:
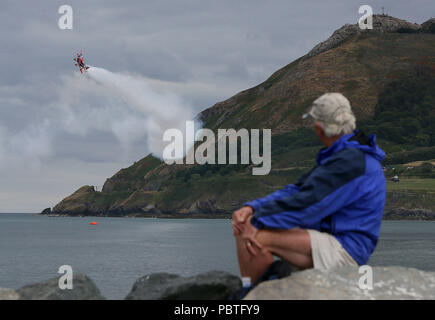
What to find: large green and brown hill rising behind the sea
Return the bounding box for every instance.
[47,16,435,217]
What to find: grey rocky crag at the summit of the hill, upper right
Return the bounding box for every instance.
[308,15,422,57]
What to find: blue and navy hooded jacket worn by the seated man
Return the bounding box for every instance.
[245,130,386,265]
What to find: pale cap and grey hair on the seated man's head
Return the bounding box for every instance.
[309,93,356,138]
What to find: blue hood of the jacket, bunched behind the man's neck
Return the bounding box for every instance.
[317,130,385,164]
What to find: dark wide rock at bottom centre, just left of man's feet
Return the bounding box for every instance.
[125,271,242,300]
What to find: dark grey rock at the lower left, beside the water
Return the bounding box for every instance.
[17,272,104,300]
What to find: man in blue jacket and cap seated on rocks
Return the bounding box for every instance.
[233,93,386,282]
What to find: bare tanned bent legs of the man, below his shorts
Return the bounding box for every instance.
[235,229,313,282]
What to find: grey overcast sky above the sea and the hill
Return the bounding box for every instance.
[0,0,435,213]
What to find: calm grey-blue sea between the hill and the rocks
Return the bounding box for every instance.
[0,213,435,299]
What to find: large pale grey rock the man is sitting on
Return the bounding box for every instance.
[245,266,435,300]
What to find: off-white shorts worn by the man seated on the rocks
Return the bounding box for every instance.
[307,229,358,269]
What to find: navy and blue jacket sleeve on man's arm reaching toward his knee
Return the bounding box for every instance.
[251,149,365,229]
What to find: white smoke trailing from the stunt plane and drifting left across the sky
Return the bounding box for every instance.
[0,67,201,168]
